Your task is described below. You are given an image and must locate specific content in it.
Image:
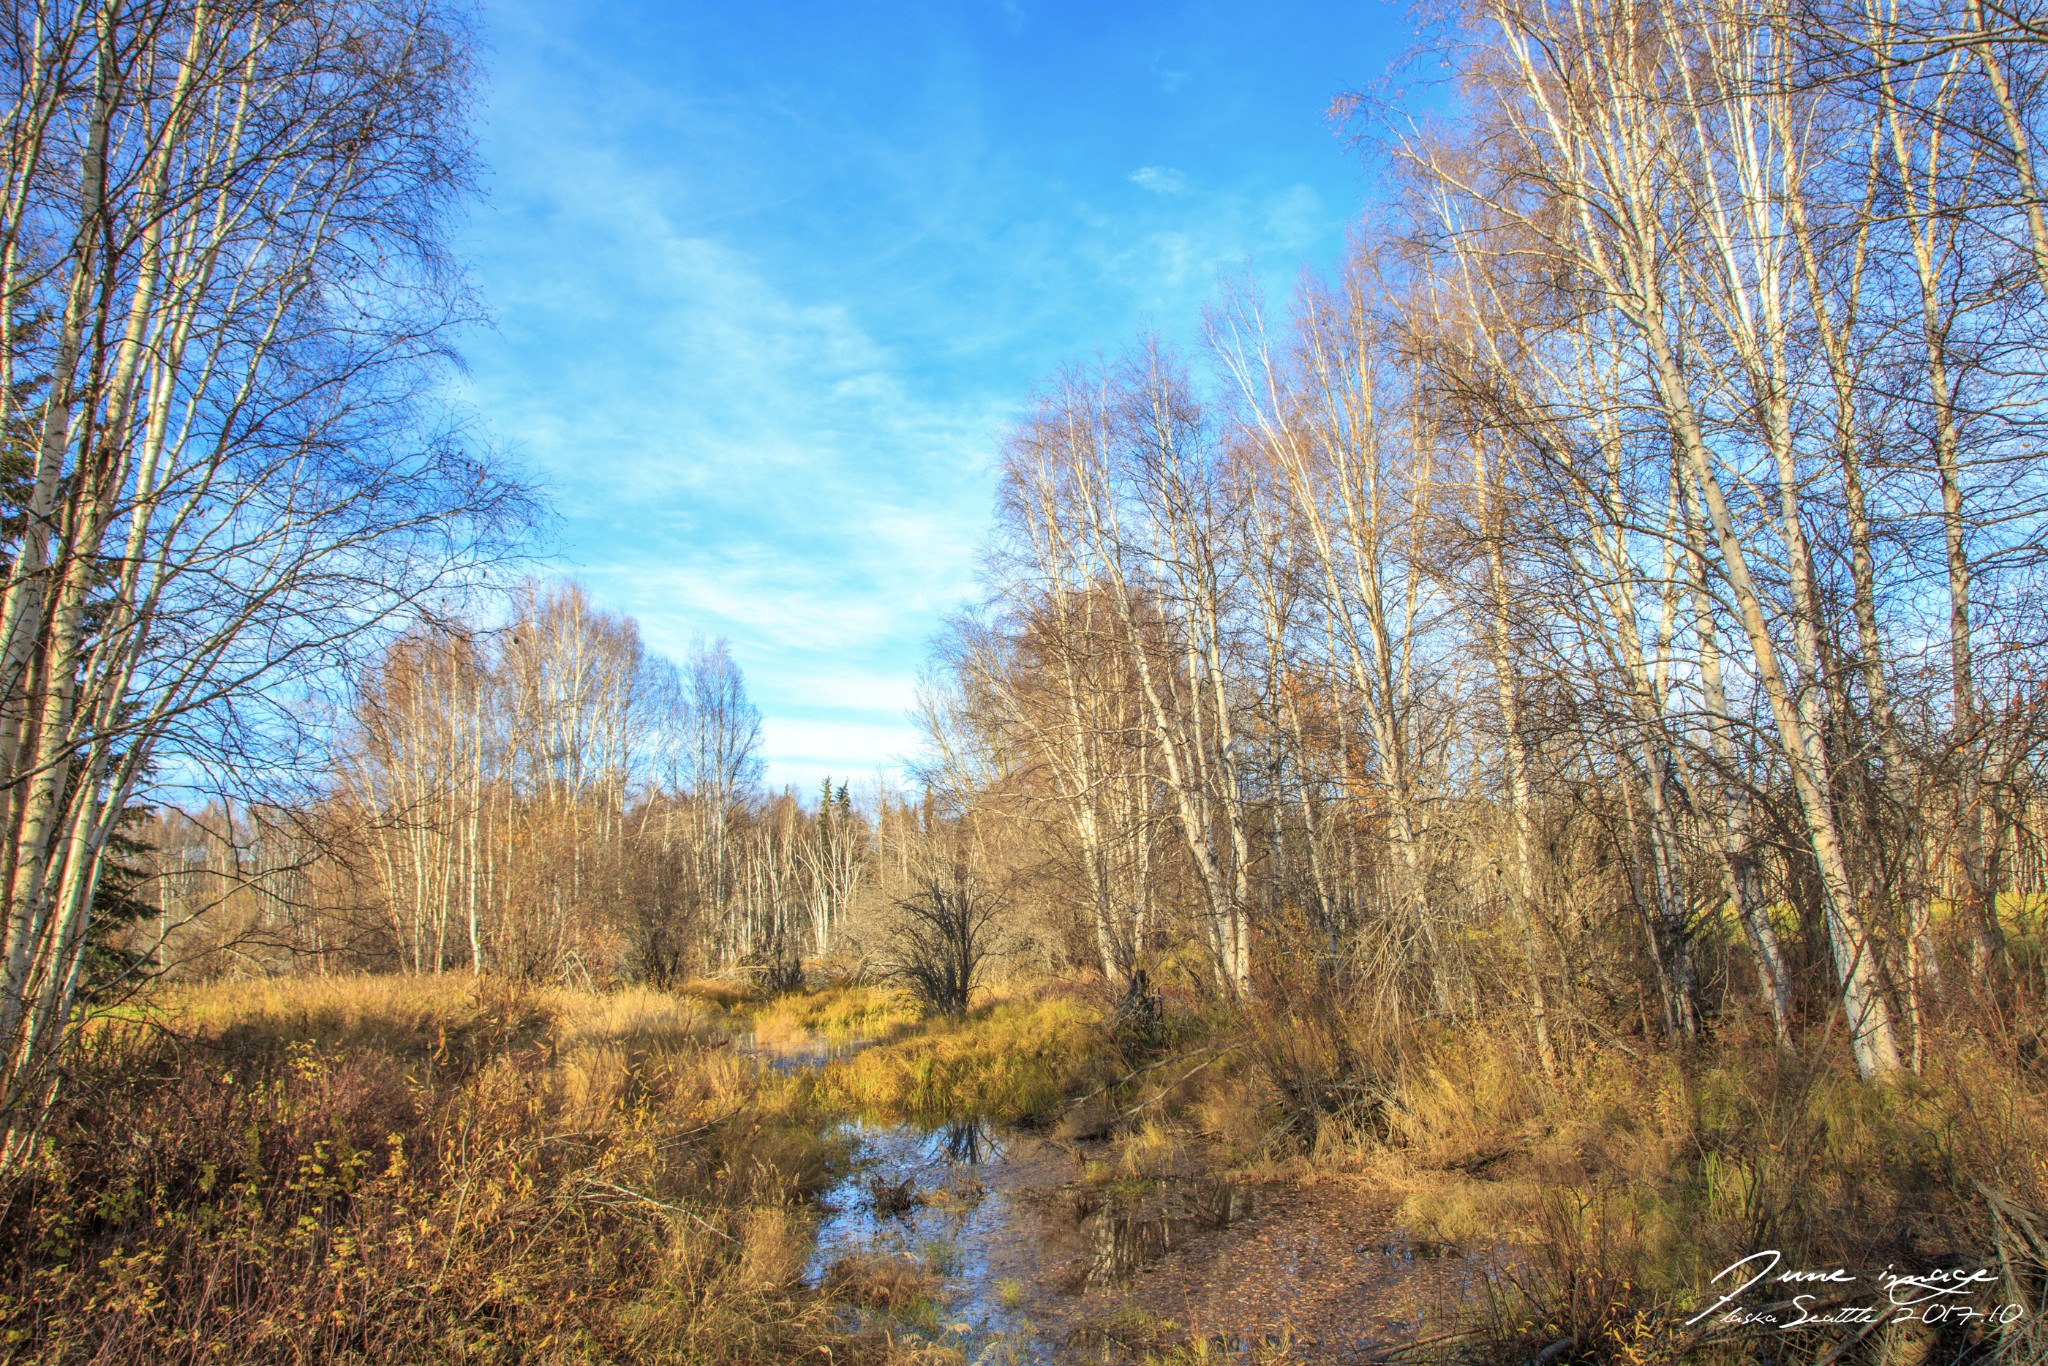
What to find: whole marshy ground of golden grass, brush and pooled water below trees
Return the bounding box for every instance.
[0,975,2048,1364]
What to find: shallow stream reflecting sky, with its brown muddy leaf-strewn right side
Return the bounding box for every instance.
[729,1040,1499,1364]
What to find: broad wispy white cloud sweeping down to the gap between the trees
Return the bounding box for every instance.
[456,45,1001,782]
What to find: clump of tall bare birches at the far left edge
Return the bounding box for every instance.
[0,0,536,1157]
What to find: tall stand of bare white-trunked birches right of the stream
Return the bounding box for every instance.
[932,0,2048,1079]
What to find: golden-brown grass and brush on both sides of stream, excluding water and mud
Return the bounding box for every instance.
[0,977,2048,1366]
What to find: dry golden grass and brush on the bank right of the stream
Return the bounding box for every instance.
[1040,970,2048,1366]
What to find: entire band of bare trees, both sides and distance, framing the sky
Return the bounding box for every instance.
[0,0,2048,1196]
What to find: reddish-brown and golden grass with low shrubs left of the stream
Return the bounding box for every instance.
[0,977,851,1366]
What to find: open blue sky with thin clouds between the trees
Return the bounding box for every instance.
[448,0,1405,788]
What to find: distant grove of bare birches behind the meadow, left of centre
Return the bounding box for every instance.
[144,584,948,987]
